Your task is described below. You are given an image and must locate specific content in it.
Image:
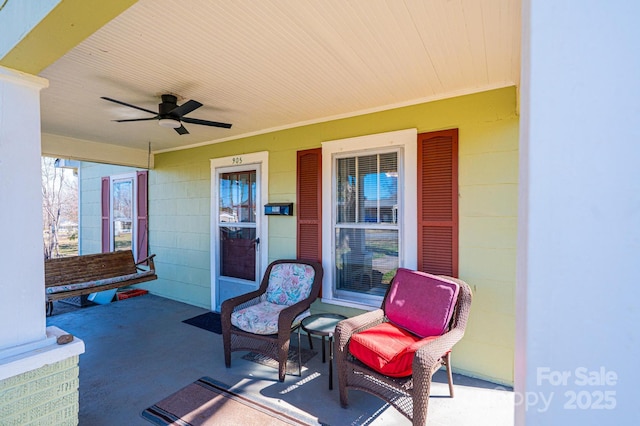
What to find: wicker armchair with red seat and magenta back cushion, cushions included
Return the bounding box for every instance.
[335,269,472,425]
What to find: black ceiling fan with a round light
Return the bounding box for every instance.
[101,95,231,135]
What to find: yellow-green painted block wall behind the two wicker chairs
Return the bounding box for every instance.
[82,87,519,384]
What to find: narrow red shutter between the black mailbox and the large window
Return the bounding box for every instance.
[296,148,322,262]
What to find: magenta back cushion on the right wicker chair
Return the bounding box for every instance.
[384,268,460,337]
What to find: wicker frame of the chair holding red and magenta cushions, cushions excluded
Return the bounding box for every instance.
[335,276,472,425]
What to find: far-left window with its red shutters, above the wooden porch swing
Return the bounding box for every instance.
[102,171,148,261]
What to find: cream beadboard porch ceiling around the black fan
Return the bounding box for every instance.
[40,0,520,152]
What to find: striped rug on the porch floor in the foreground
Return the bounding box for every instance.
[141,377,320,426]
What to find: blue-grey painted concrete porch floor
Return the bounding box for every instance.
[47,294,514,426]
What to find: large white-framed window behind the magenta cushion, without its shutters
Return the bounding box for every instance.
[322,129,417,308]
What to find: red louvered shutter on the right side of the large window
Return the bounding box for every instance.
[418,129,458,277]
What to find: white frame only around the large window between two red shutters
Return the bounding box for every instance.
[322,129,418,310]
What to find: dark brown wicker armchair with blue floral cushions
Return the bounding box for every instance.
[221,260,323,382]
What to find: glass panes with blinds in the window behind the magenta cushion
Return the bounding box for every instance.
[334,151,400,298]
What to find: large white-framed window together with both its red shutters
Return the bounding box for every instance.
[312,129,458,309]
